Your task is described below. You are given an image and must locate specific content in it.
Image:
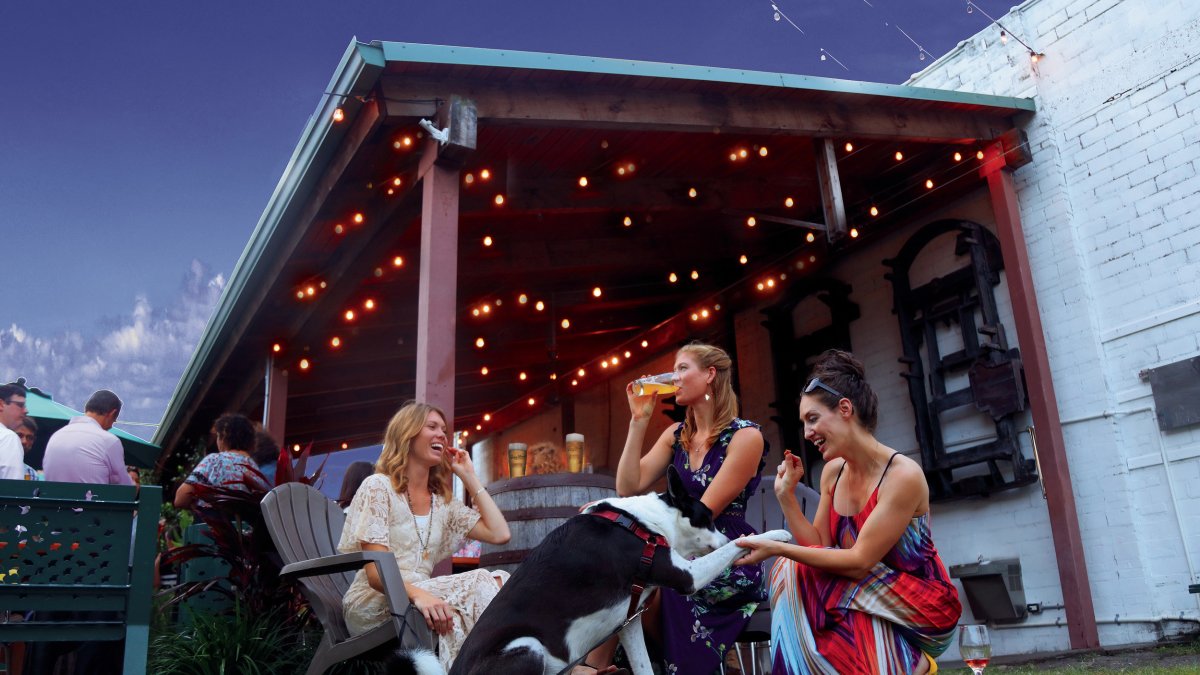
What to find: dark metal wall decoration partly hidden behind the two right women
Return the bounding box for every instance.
[763,277,859,485]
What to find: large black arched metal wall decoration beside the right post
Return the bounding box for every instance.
[884,220,1038,501]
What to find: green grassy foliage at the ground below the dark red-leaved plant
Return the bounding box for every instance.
[149,603,316,675]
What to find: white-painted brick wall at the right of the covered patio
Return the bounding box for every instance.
[907,0,1200,653]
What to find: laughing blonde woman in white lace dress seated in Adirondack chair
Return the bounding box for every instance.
[337,401,510,670]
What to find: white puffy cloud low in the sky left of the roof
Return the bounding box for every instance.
[0,261,226,437]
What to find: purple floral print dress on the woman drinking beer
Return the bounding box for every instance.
[661,418,768,675]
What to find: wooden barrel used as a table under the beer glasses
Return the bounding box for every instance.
[479,473,617,573]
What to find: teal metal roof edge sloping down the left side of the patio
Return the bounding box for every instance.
[152,40,384,448]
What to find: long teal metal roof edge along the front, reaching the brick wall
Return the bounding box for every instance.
[371,41,1034,112]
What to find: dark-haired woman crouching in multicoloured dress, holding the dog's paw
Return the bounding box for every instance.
[738,351,962,675]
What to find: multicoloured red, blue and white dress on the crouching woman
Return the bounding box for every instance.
[770,455,962,675]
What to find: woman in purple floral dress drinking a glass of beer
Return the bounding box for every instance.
[576,344,767,675]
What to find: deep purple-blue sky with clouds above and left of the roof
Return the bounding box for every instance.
[0,0,1008,431]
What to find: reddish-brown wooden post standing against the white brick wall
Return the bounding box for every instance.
[980,142,1100,650]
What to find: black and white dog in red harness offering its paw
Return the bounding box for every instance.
[391,467,791,675]
